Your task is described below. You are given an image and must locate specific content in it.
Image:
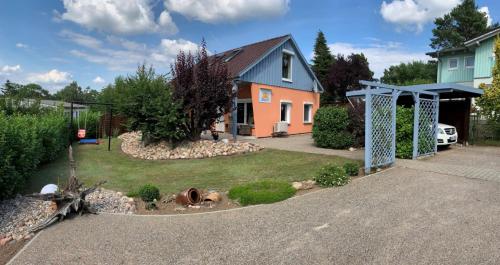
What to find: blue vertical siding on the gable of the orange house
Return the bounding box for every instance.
[241,40,314,91]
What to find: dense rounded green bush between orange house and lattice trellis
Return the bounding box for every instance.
[313,106,354,149]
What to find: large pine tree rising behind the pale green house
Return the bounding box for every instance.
[430,0,489,50]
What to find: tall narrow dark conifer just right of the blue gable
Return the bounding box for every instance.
[312,30,334,87]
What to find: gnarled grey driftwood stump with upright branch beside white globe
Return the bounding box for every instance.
[30,146,105,232]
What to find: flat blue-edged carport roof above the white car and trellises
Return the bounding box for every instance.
[347,80,484,98]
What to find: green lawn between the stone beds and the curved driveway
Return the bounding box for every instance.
[27,139,360,193]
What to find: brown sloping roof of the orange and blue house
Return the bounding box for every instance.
[214,35,290,77]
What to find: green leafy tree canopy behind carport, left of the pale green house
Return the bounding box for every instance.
[380,61,437,86]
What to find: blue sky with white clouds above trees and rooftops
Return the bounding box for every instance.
[0,0,500,92]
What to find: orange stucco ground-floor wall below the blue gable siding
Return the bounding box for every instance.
[250,83,319,137]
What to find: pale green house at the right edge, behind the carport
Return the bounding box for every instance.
[427,28,500,88]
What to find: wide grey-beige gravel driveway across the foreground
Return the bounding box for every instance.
[11,148,500,264]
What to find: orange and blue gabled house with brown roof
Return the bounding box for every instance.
[215,35,323,137]
